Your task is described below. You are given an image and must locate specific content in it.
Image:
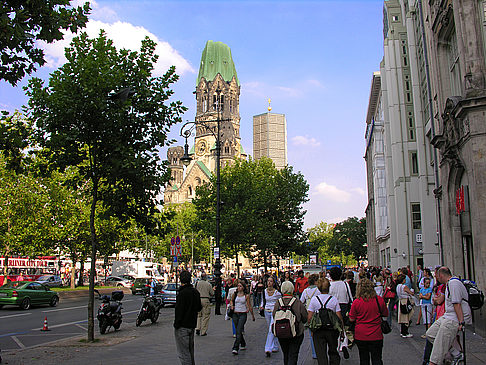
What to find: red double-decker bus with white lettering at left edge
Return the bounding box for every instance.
[0,256,59,285]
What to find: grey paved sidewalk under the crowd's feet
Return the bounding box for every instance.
[3,308,486,365]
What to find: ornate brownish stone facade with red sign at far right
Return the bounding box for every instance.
[423,0,486,335]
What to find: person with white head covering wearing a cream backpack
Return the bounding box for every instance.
[272,281,307,365]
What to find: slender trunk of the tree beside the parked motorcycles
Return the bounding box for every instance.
[88,177,98,342]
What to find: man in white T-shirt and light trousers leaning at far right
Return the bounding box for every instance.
[424,266,472,365]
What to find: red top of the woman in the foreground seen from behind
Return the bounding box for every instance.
[349,295,388,341]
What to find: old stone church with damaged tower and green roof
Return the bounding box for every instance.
[164,41,247,204]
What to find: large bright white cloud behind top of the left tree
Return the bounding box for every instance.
[39,7,196,76]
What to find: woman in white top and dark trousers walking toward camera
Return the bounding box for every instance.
[230,280,255,355]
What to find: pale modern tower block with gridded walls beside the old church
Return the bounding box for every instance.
[253,107,287,169]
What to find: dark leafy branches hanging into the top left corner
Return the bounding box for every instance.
[0,0,90,86]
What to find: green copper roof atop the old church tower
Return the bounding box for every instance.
[197,41,240,86]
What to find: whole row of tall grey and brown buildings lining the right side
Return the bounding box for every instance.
[365,0,486,335]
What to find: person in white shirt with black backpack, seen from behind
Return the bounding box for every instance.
[307,277,343,365]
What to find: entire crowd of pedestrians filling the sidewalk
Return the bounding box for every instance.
[174,267,480,365]
